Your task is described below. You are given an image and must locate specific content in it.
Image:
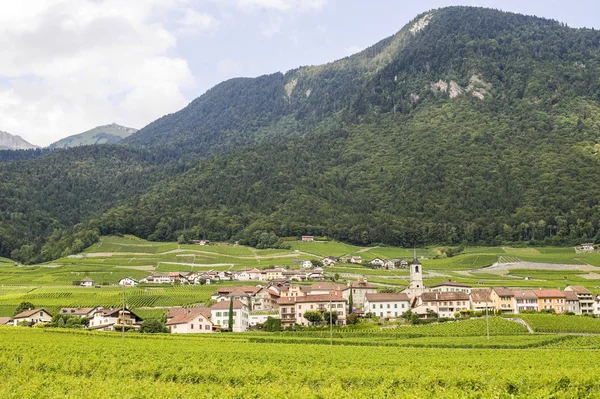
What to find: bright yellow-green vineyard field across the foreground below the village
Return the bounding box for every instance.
[0,327,600,399]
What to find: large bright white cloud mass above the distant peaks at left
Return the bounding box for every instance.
[0,0,203,145]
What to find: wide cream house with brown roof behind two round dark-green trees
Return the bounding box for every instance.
[277,294,348,328]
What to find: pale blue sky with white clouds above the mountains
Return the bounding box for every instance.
[0,0,600,146]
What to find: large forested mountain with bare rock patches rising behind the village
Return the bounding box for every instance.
[0,7,600,262]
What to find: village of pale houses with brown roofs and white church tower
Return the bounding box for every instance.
[8,252,600,334]
